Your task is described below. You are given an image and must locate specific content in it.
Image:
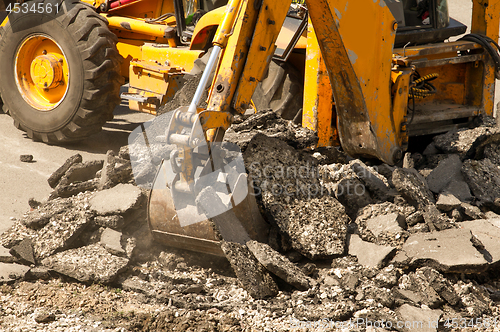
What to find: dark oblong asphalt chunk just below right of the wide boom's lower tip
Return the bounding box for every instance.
[392,168,435,209]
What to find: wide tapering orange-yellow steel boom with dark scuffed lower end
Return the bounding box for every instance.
[306,0,402,164]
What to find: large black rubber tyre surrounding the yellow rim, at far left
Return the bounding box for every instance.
[0,0,123,143]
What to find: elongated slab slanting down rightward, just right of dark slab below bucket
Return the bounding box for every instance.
[247,241,311,291]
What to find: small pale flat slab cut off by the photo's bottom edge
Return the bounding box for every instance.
[396,304,443,332]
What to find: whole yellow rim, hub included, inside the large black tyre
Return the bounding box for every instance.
[14,35,69,111]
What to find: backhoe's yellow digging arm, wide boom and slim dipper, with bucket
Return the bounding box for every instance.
[148,0,409,254]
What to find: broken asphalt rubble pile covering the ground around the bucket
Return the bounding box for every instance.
[0,112,500,331]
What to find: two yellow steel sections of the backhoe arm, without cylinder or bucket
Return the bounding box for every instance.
[208,0,406,164]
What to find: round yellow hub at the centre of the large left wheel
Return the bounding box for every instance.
[30,54,63,89]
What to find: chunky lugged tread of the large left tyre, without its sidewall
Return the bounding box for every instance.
[0,0,124,144]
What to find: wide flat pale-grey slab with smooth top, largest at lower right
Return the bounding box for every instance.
[392,229,488,273]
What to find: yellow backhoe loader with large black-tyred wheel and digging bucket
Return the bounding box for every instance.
[0,0,500,253]
